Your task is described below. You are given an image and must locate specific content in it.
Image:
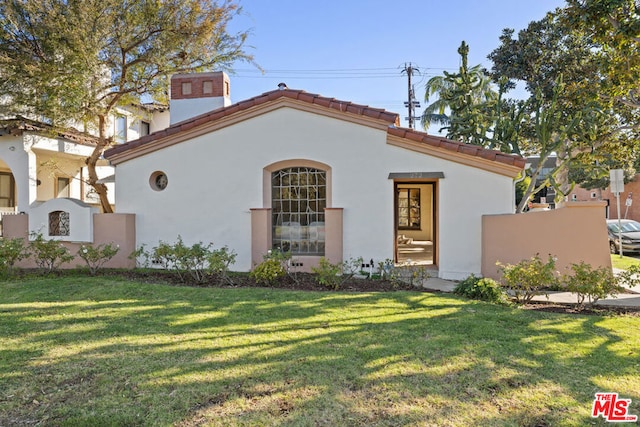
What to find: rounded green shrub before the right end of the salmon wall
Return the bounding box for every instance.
[562,261,623,310]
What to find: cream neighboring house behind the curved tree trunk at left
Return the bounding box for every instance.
[0,104,169,235]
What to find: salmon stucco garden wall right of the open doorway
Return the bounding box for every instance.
[482,202,611,279]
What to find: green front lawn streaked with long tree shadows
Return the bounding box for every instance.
[0,277,640,426]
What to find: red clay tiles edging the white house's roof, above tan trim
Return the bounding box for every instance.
[105,89,525,172]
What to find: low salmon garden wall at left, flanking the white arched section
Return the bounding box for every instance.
[2,214,136,269]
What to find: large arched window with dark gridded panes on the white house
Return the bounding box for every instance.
[271,166,327,255]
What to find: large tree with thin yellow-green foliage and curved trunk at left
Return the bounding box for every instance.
[0,0,252,212]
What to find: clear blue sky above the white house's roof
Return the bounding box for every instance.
[230,0,564,130]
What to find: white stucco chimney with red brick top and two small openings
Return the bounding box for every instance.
[169,71,231,124]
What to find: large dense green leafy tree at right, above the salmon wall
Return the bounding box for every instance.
[489,6,640,206]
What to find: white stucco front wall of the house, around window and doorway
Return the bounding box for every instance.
[116,108,513,279]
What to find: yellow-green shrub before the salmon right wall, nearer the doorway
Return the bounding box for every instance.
[497,255,558,304]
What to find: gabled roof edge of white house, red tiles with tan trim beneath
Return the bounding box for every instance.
[105,89,525,177]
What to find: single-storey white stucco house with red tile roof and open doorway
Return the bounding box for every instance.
[105,73,525,279]
